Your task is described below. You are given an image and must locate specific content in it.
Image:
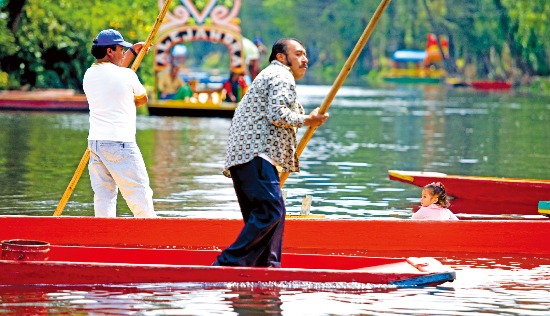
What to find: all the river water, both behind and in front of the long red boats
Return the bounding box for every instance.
[0,86,550,315]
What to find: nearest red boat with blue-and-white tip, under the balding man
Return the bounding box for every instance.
[0,246,455,286]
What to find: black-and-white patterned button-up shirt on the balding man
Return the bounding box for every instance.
[223,61,306,177]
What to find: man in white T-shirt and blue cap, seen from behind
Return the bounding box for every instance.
[83,29,156,217]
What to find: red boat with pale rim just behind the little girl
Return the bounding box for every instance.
[388,170,550,215]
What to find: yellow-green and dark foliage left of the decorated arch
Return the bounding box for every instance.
[0,0,158,90]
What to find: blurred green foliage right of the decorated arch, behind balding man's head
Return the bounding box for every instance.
[248,0,550,83]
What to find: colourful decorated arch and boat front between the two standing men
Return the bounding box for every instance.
[149,0,257,117]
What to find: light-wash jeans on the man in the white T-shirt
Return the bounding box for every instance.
[88,140,157,217]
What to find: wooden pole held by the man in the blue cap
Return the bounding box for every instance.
[53,0,172,216]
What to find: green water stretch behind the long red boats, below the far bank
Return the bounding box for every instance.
[0,86,550,218]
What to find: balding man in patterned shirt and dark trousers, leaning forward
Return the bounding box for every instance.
[213,38,328,267]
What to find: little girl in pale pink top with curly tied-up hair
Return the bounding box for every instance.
[412,182,458,220]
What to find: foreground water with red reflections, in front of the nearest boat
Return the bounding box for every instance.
[0,258,550,315]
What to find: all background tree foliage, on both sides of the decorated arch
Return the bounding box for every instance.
[0,0,550,90]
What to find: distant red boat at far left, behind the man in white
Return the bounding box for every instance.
[0,89,88,111]
